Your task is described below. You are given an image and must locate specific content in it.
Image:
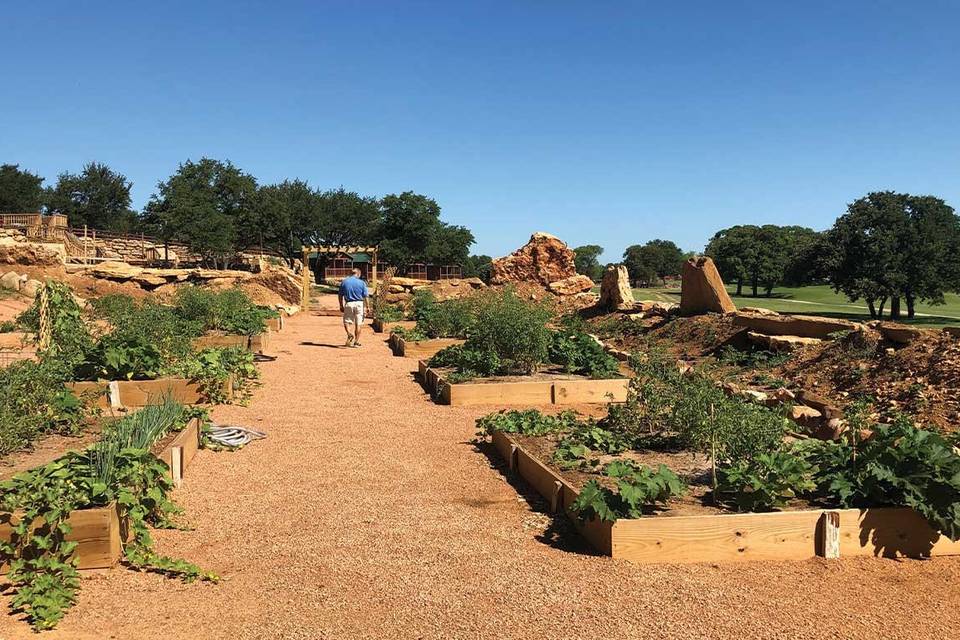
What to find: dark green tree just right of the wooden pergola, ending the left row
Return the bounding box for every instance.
[379,191,474,266]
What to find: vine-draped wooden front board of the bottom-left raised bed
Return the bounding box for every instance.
[0,504,123,573]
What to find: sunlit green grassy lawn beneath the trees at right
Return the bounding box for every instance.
[633,285,960,327]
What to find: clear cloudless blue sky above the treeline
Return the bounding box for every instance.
[0,0,960,261]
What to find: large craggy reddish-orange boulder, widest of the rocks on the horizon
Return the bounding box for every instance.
[490,232,577,287]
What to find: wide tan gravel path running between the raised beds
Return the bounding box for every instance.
[0,302,960,640]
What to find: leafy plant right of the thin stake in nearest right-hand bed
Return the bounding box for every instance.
[717,451,816,511]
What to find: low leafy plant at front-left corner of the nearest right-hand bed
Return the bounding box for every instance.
[571,460,686,522]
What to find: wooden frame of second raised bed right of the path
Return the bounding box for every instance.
[419,360,630,406]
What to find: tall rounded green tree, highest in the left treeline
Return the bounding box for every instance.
[144,158,256,267]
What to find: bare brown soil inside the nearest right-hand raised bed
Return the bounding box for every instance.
[510,433,819,517]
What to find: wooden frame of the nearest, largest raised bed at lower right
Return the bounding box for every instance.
[493,432,960,564]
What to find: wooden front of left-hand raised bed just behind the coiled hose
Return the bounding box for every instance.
[67,378,233,409]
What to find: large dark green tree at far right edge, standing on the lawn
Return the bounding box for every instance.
[826,191,960,318]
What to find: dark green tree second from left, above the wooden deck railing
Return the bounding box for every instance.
[47,162,137,231]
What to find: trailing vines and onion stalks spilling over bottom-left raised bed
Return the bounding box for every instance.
[0,402,217,630]
